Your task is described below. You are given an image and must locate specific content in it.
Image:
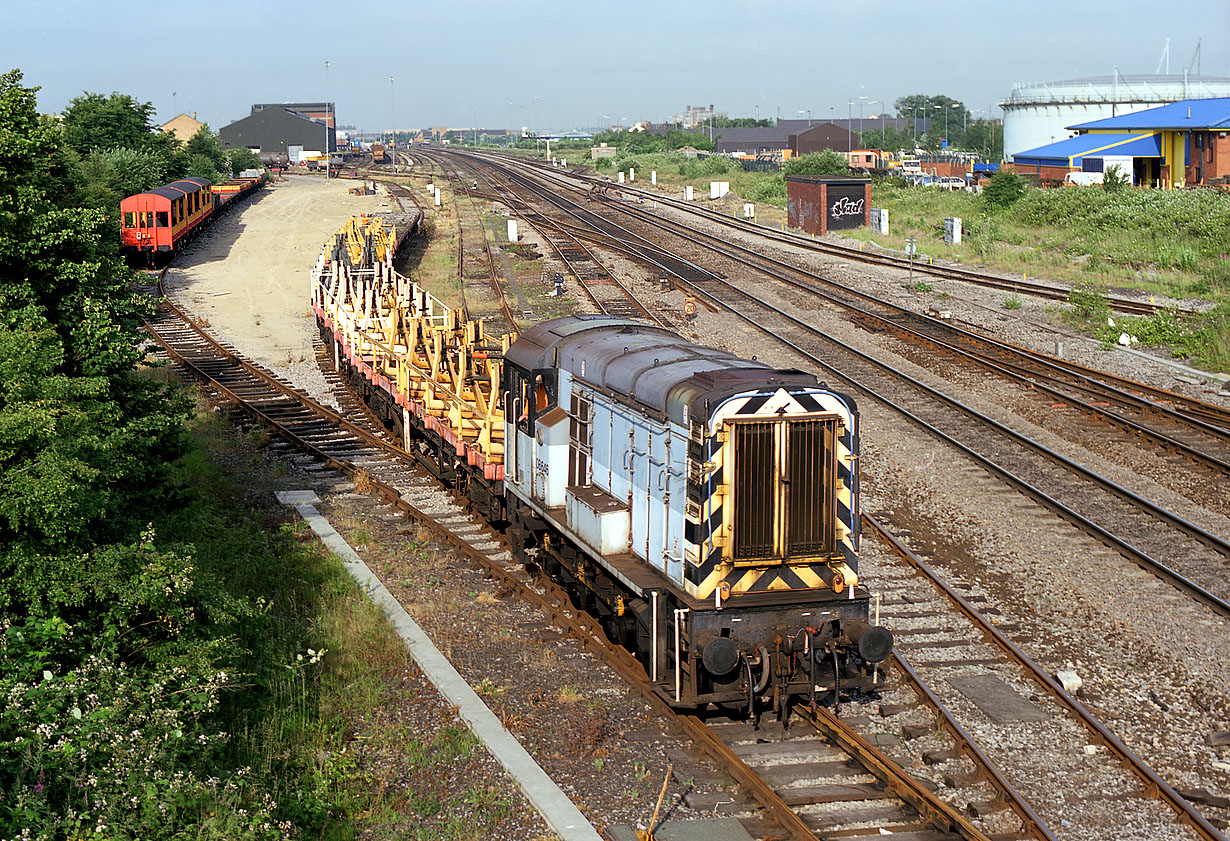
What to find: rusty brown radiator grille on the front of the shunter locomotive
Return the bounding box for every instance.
[727,417,843,564]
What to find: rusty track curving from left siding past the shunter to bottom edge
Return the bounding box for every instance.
[150,285,1216,841]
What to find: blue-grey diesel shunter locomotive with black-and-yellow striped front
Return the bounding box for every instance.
[503,316,892,709]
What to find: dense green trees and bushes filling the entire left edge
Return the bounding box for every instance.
[0,70,320,840]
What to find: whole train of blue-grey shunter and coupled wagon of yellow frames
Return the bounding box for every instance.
[312,218,893,713]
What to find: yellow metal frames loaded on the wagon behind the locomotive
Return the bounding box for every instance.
[311,216,513,481]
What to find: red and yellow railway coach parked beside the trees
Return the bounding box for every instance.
[119,178,214,259]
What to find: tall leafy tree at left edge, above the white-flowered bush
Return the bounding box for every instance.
[0,70,183,580]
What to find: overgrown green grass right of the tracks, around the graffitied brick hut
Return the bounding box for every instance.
[570,152,1230,371]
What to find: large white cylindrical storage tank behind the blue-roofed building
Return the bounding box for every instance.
[999,74,1230,160]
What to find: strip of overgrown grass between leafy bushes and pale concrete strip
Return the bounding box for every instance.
[167,405,407,839]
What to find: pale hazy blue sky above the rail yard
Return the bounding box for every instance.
[9,0,1230,132]
